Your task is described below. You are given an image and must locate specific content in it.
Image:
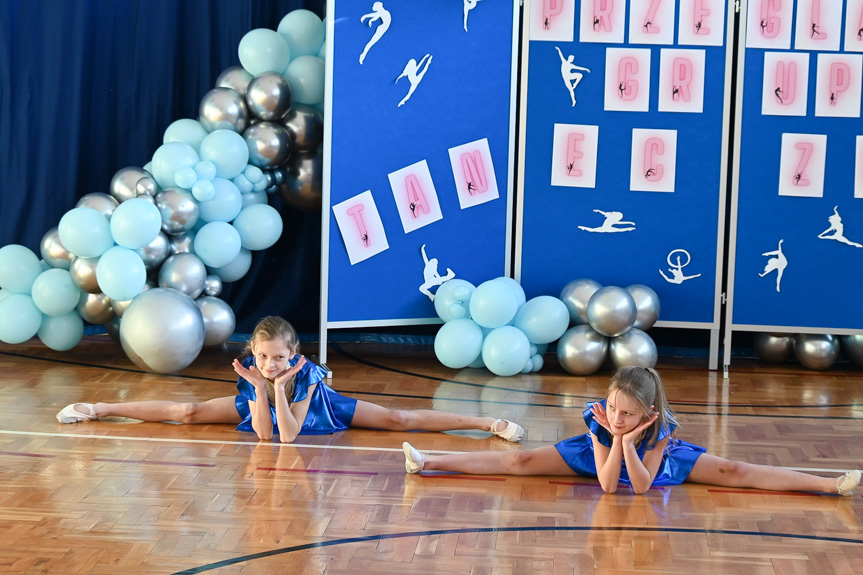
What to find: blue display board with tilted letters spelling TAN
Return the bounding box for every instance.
[321,0,518,356]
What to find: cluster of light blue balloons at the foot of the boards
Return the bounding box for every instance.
[434,277,569,376]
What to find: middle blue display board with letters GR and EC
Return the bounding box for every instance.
[516,0,732,340]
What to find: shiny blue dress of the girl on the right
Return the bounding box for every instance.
[555,399,707,486]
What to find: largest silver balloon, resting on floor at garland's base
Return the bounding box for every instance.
[120,288,204,373]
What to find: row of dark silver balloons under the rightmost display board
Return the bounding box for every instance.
[752,333,863,371]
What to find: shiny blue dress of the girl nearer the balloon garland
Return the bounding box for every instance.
[235,355,357,435]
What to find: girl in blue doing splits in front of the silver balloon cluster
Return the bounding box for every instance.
[403,367,861,496]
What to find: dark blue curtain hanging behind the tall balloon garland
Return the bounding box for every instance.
[0,0,324,333]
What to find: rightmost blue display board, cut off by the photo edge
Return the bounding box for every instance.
[726,0,863,346]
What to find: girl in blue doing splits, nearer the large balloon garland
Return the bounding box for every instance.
[57,316,524,443]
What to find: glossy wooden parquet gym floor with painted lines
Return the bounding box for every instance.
[0,336,863,575]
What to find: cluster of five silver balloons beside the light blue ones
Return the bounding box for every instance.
[557,279,659,375]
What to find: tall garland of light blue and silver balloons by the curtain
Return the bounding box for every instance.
[0,10,324,378]
